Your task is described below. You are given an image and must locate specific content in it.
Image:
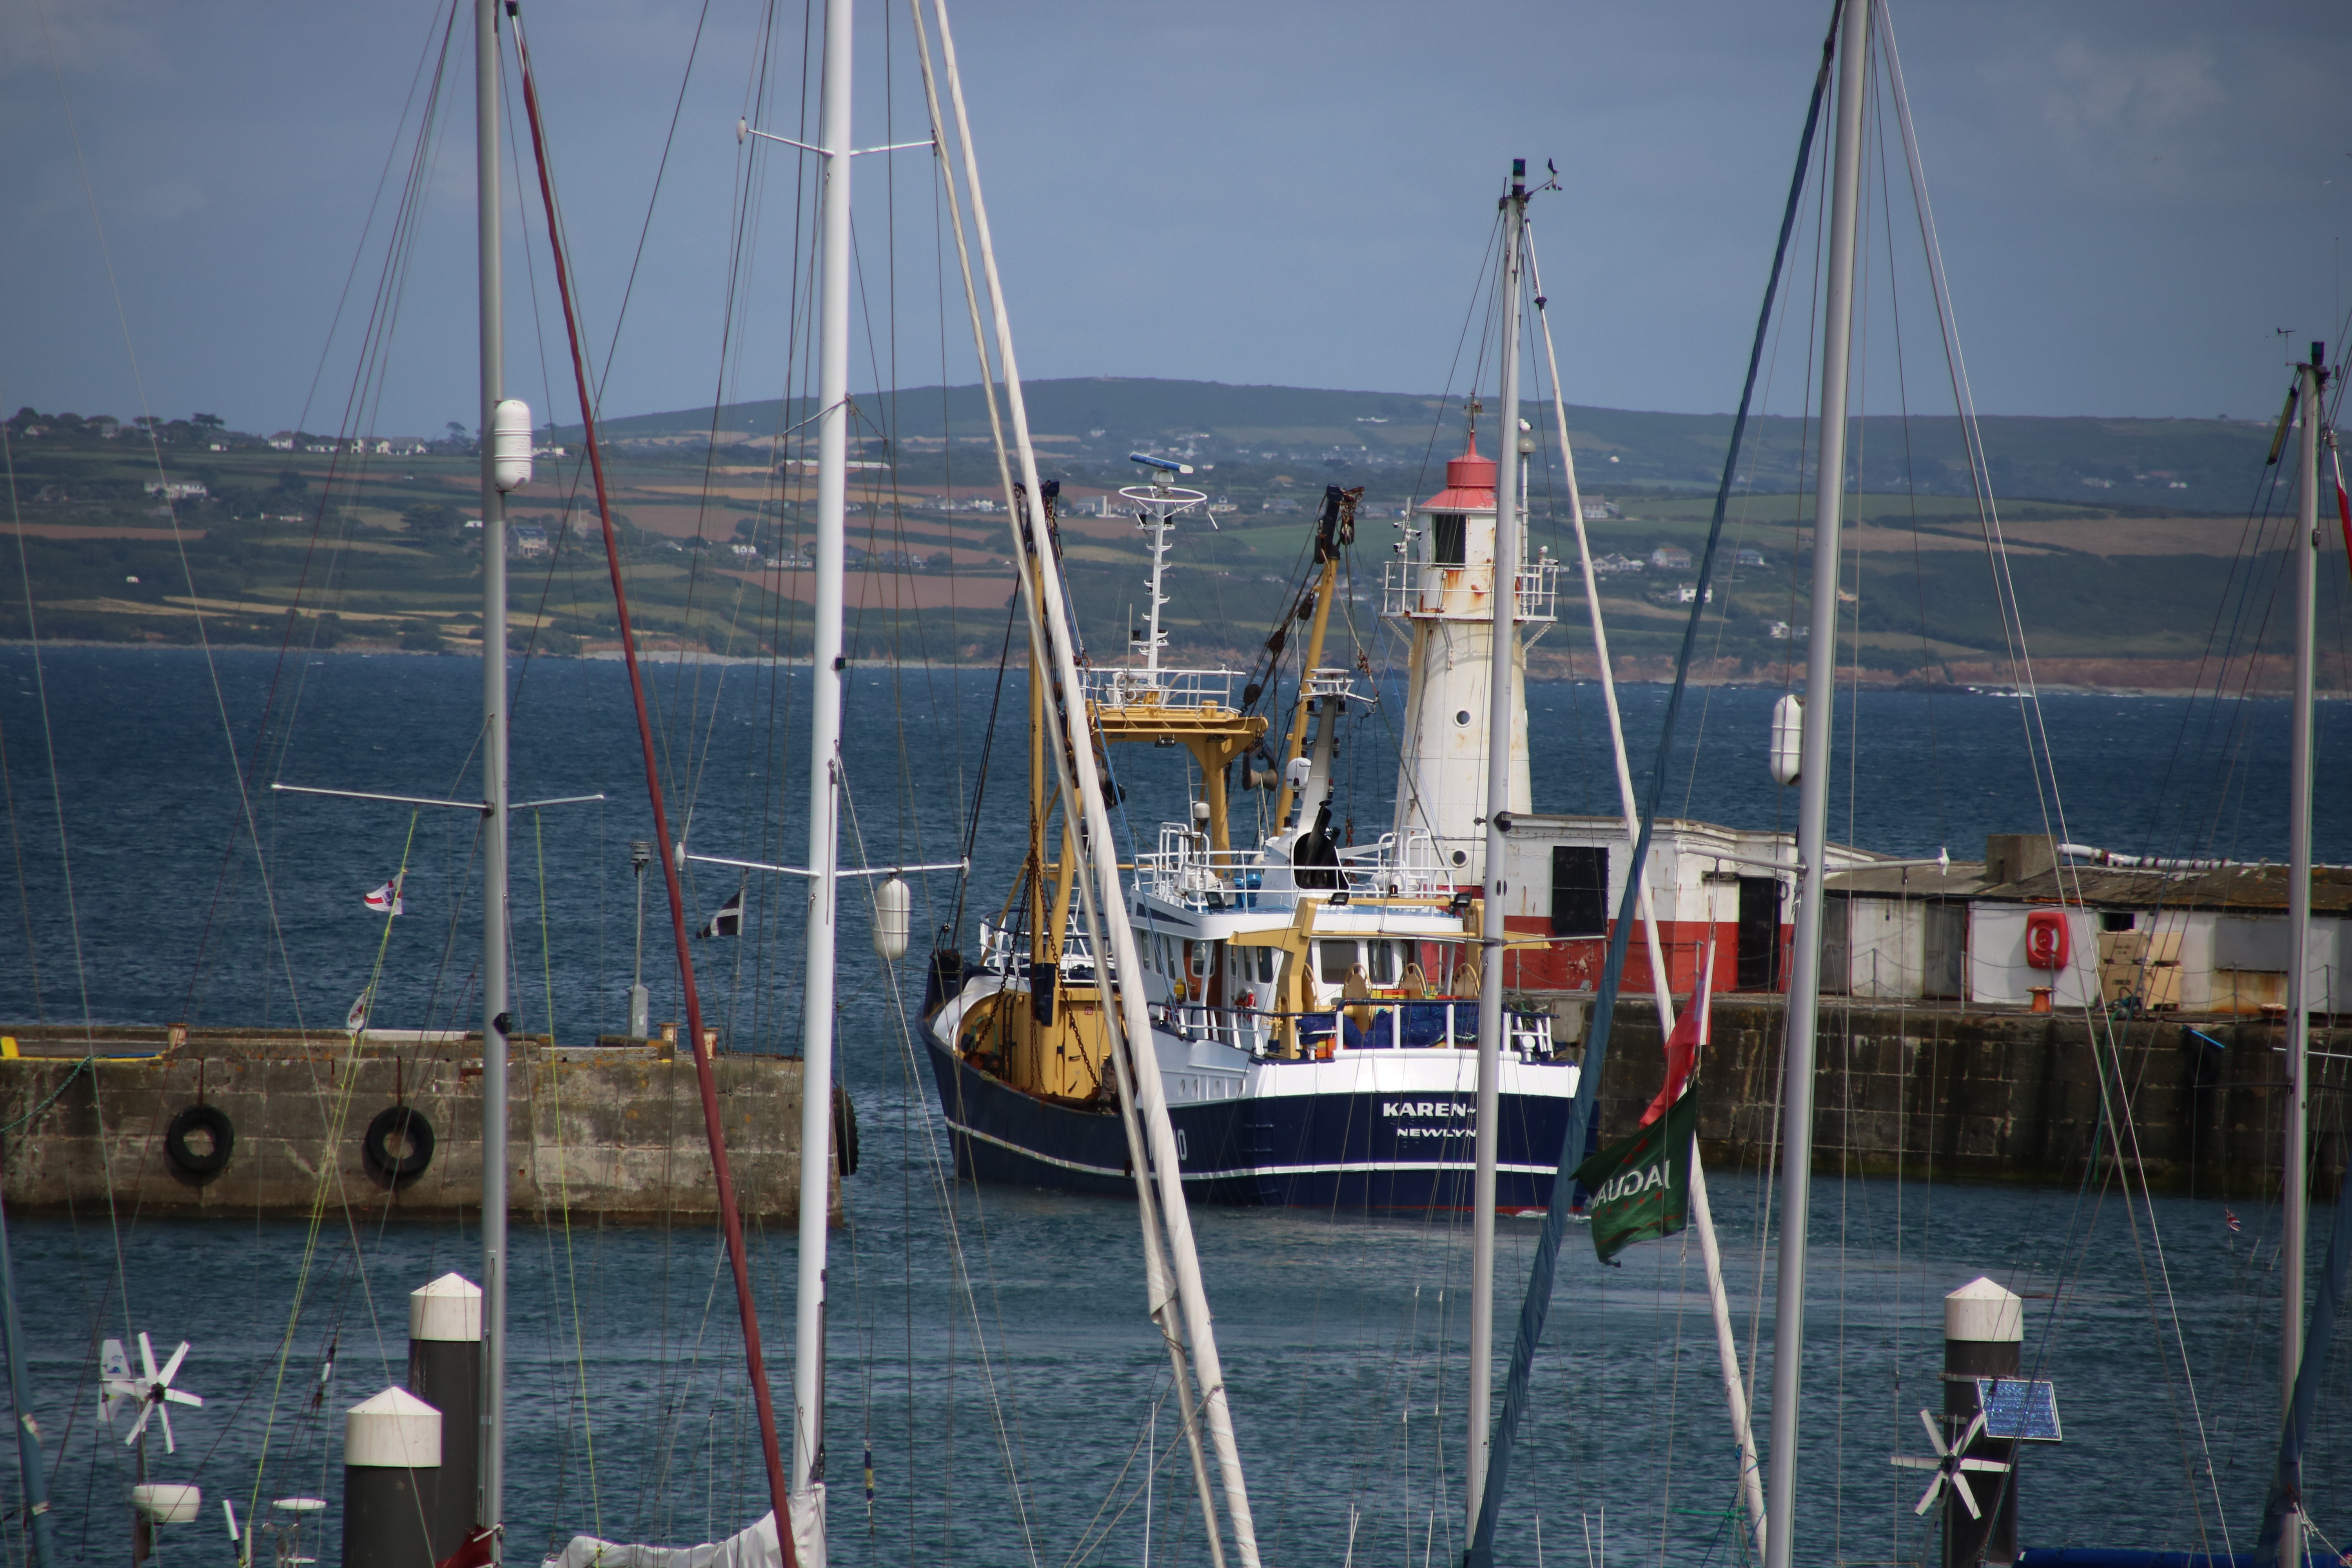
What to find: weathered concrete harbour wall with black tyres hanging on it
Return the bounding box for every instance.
[0,1025,840,1222]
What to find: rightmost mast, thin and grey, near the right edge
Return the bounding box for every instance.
[2279,343,2326,1439]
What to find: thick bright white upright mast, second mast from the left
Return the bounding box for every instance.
[793,0,854,1500]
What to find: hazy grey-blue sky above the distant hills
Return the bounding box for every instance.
[0,0,2352,435]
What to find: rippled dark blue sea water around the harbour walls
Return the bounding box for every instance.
[0,646,2352,1568]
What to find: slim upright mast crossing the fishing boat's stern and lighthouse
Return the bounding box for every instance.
[1463,158,1524,1530]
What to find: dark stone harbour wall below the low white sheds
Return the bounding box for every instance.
[1526,995,2352,1199]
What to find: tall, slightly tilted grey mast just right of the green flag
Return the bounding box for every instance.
[1764,0,1870,1568]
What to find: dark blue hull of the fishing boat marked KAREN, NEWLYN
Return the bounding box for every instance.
[924,1030,1569,1210]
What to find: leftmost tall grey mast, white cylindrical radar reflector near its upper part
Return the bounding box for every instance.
[473,0,513,1530]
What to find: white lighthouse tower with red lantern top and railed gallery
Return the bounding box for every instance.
[1381,423,1559,886]
